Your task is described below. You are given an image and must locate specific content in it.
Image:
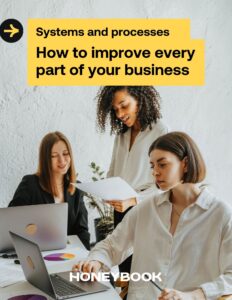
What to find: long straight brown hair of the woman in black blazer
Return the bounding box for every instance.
[36,131,76,196]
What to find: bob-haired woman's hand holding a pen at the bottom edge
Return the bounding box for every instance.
[158,289,206,300]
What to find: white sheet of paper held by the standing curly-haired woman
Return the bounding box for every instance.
[73,177,138,200]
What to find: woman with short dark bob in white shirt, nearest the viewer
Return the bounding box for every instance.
[74,132,232,300]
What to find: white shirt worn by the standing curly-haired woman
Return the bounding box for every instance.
[107,120,168,200]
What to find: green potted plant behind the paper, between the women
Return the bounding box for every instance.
[85,162,114,242]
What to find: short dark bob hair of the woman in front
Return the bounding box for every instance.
[148,131,206,183]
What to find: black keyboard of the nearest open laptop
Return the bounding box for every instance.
[50,275,85,296]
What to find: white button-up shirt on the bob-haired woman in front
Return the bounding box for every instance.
[89,188,232,300]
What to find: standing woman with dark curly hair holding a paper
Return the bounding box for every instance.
[97,86,167,272]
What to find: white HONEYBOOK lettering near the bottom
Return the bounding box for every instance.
[69,272,162,282]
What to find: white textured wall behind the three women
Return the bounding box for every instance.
[0,0,232,239]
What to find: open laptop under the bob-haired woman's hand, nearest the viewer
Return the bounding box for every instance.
[10,232,109,299]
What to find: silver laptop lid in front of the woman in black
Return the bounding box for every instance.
[0,203,68,252]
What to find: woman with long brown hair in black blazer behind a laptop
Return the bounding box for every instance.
[9,131,90,249]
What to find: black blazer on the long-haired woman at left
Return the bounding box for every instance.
[9,175,90,250]
